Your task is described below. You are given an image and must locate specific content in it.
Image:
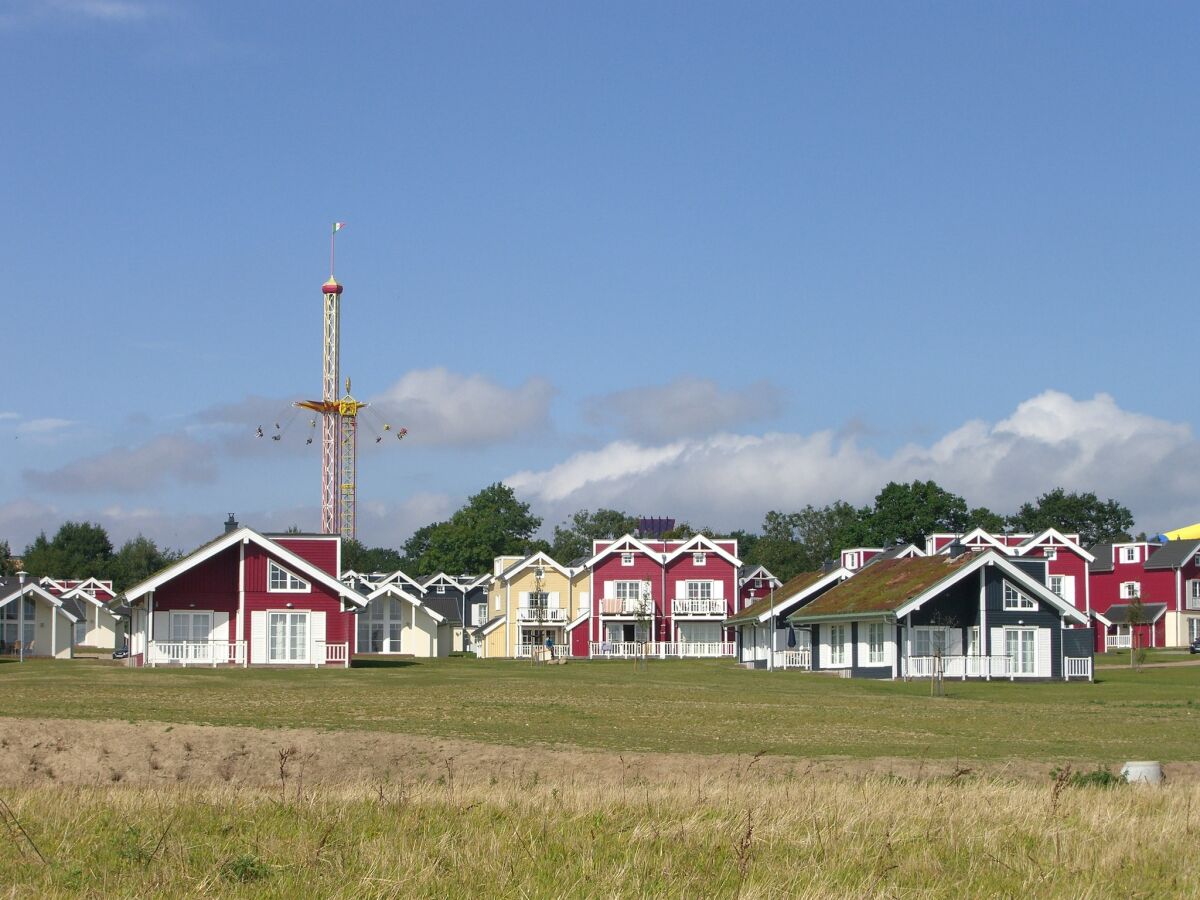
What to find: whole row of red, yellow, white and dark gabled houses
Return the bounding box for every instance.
[0,521,1200,678]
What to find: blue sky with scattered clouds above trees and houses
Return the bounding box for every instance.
[0,0,1200,548]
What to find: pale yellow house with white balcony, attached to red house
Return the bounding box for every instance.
[475,553,592,659]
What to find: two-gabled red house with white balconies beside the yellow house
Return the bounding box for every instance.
[583,534,742,656]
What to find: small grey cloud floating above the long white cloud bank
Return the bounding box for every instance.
[584,378,784,442]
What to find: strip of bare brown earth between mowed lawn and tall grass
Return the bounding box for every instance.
[0,718,1200,786]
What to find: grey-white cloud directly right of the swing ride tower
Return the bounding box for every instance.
[371,367,554,446]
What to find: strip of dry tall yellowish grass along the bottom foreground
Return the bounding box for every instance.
[0,757,1200,898]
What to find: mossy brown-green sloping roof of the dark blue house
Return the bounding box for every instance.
[788,553,979,622]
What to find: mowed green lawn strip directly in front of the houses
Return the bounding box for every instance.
[0,659,1200,764]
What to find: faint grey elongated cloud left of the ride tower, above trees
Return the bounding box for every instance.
[22,434,217,493]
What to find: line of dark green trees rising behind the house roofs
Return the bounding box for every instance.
[0,481,1133,590]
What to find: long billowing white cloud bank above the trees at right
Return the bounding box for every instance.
[505,391,1200,530]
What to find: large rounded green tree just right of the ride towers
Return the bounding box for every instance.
[404,482,545,575]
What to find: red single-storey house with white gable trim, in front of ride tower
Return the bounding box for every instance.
[124,523,367,666]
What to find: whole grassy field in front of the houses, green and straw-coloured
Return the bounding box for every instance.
[0,660,1200,898]
